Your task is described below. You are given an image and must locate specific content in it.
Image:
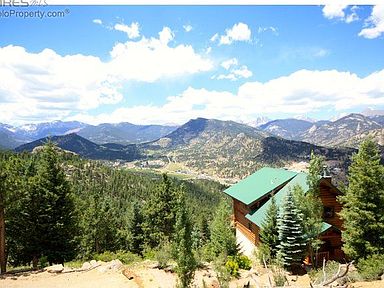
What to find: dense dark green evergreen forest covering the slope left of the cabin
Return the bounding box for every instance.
[0,143,229,276]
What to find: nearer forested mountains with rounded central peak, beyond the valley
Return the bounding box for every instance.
[16,118,356,179]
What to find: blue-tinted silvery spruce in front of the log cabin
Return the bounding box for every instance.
[278,191,306,268]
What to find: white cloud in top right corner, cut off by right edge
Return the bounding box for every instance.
[359,4,384,39]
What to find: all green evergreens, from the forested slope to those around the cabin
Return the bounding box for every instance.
[0,139,384,287]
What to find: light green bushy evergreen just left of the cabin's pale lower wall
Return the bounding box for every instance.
[210,200,237,256]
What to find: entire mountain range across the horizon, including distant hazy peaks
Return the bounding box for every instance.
[4,114,384,179]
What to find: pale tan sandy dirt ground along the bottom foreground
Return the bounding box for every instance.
[0,261,384,288]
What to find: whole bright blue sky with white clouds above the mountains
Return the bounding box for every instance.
[0,6,384,125]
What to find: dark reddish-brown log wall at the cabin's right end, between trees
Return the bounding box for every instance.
[320,179,343,229]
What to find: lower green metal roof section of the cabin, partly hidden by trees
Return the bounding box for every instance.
[245,173,309,227]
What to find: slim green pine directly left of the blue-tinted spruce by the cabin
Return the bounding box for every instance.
[260,197,279,258]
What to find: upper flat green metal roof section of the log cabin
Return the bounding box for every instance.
[224,167,298,206]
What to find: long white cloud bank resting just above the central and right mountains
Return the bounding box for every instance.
[68,70,384,124]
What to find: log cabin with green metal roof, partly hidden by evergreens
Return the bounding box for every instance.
[224,167,345,263]
